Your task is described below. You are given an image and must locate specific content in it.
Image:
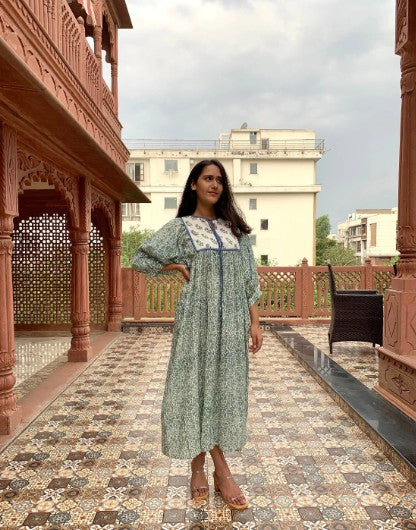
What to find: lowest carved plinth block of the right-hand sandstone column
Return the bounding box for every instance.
[374,346,416,420]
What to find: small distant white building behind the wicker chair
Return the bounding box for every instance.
[338,208,399,265]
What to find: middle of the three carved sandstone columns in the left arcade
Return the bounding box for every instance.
[68,178,91,361]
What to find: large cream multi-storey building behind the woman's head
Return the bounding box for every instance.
[123,128,324,266]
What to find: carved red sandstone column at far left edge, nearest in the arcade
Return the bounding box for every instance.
[0,123,22,428]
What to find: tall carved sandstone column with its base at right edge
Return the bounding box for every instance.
[376,0,416,419]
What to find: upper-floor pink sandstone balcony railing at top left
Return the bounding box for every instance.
[0,0,129,168]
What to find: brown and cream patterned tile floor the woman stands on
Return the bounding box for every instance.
[0,328,416,530]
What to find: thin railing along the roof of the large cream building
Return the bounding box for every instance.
[123,138,324,154]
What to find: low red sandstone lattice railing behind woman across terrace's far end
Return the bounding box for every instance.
[122,260,393,323]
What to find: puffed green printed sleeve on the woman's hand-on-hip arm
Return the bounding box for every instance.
[131,218,181,276]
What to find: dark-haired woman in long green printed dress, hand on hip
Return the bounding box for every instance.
[132,160,262,510]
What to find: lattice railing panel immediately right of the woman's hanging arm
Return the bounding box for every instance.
[259,271,296,316]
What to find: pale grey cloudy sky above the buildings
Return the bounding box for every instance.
[119,0,400,231]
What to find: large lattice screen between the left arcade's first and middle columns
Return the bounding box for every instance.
[12,214,72,325]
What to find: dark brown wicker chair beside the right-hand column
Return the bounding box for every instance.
[328,264,383,353]
